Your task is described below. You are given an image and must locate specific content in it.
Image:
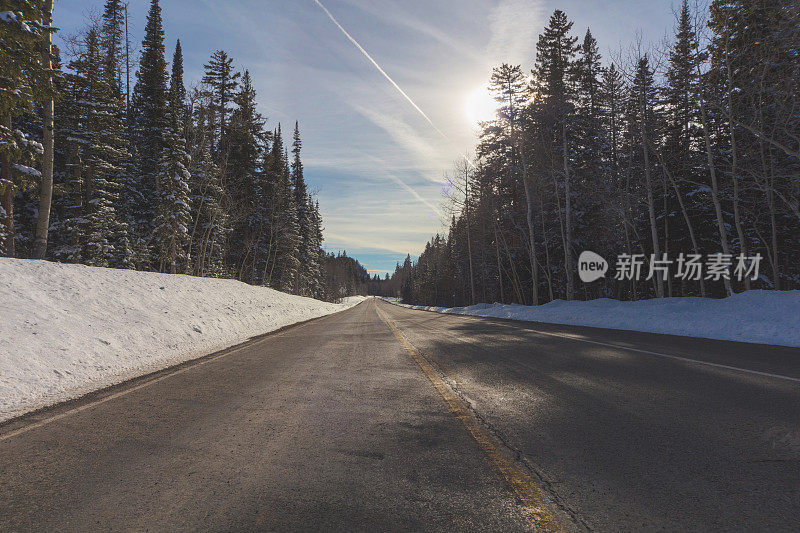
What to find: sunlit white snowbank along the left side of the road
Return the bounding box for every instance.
[0,259,364,421]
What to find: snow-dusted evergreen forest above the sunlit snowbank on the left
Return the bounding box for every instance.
[0,0,357,299]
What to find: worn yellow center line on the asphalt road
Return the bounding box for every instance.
[375,305,563,531]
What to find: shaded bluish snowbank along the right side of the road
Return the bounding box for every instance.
[386,291,800,347]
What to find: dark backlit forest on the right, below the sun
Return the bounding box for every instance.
[389,0,800,306]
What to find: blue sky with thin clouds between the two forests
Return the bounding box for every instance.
[55,0,678,274]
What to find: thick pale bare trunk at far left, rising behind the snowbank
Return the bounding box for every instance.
[33,0,55,259]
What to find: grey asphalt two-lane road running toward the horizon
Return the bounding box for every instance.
[0,300,800,531]
